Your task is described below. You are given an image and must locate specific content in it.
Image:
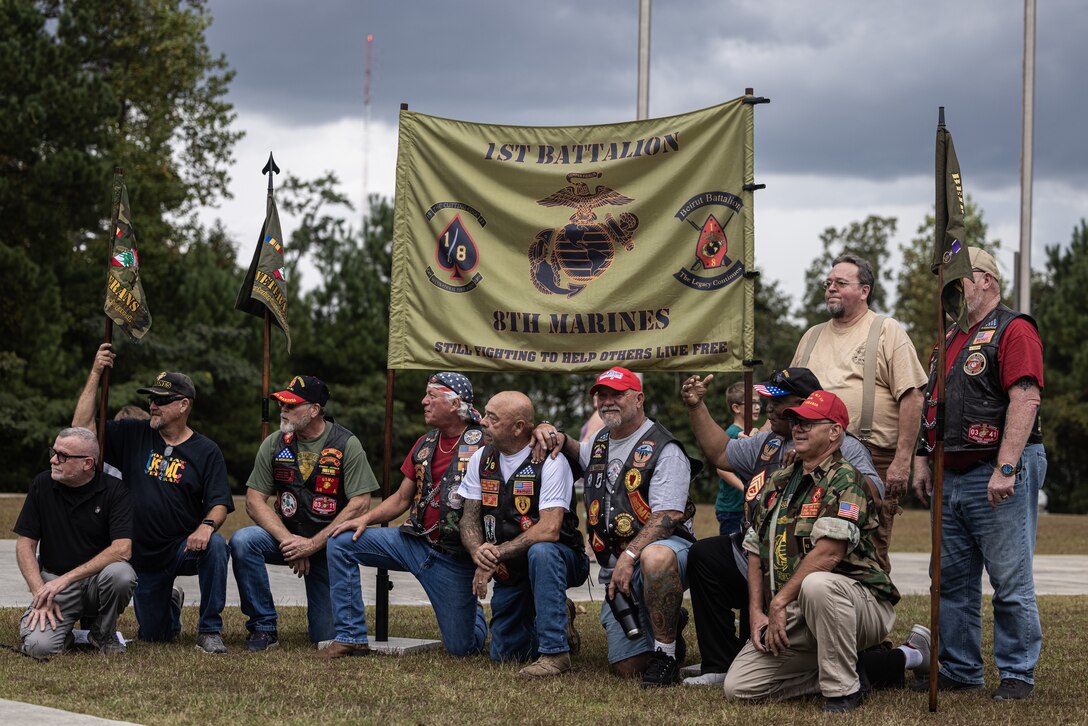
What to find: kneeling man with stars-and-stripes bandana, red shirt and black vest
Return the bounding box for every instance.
[318,371,487,659]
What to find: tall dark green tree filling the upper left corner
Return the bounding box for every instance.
[0,0,240,487]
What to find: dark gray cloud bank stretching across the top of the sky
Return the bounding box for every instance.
[209,0,1088,188]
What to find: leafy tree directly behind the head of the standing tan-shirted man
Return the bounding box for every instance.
[798,214,899,329]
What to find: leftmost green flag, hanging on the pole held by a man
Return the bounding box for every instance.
[104,174,151,341]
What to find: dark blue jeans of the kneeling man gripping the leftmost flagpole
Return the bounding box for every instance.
[133,532,231,642]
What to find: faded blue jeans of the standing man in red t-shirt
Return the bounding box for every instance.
[940,444,1047,685]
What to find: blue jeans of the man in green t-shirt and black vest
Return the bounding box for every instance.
[231,526,334,643]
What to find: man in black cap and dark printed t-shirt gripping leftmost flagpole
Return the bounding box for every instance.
[72,343,234,653]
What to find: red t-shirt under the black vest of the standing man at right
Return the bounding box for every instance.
[926,316,1042,468]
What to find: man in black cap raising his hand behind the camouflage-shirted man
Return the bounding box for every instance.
[680,368,882,686]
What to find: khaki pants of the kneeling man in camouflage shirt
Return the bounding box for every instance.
[724,573,895,701]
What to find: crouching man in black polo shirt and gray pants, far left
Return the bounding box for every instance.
[14,429,136,657]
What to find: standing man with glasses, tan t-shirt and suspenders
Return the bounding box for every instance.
[790,255,926,573]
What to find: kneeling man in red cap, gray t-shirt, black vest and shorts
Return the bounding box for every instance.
[533,367,702,688]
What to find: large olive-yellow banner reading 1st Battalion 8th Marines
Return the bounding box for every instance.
[388,98,754,372]
